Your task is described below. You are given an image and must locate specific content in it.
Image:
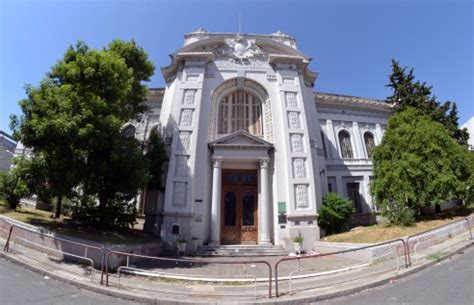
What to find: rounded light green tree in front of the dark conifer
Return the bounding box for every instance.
[370,107,472,224]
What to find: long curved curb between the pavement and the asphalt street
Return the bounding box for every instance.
[0,241,474,305]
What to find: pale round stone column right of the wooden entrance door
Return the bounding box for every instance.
[259,159,271,244]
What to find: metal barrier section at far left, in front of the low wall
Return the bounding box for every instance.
[3,220,105,285]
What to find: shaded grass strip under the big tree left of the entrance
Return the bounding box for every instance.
[0,200,158,245]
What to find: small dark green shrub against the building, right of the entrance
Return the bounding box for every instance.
[318,193,355,234]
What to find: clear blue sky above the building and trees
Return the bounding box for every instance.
[0,0,474,131]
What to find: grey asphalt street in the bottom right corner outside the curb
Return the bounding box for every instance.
[315,247,474,305]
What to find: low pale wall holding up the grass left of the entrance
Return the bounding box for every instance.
[0,216,167,270]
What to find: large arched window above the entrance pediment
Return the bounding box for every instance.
[218,91,263,136]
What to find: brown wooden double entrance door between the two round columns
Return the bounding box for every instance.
[221,170,258,244]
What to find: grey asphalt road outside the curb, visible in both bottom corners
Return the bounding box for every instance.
[0,247,474,305]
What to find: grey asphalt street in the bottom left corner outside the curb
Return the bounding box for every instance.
[0,258,143,305]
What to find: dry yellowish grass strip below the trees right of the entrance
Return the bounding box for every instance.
[323,207,472,243]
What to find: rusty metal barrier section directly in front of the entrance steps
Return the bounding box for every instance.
[105,251,272,298]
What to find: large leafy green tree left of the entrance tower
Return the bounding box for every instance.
[11,40,154,225]
